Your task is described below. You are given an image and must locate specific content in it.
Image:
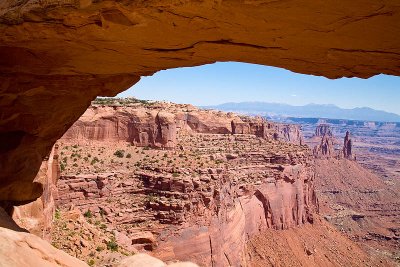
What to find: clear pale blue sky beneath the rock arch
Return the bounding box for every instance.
[119,62,400,114]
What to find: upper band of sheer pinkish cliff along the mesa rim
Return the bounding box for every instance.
[62,103,303,149]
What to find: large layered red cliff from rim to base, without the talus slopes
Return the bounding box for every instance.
[57,103,318,266]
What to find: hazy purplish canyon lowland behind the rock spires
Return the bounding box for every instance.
[290,118,400,182]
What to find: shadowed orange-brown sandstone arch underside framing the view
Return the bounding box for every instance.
[0,0,400,204]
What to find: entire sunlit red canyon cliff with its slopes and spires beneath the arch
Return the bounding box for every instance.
[3,99,399,266]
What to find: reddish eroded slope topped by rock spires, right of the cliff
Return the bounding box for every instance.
[308,124,400,261]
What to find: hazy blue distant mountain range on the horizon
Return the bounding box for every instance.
[202,102,400,122]
